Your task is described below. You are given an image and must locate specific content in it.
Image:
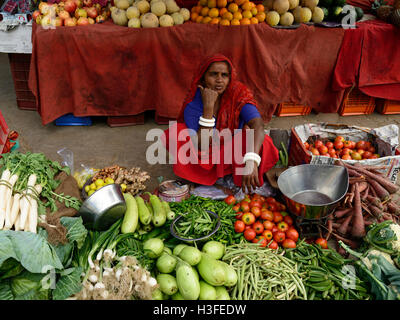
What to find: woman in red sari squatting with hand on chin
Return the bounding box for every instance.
[164,55,279,192]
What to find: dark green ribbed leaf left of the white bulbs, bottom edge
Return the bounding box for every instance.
[53,267,83,300]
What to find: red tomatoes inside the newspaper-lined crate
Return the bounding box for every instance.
[304,136,380,160]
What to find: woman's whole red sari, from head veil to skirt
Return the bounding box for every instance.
[163,55,279,186]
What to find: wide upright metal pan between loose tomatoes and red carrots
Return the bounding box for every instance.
[278,164,349,220]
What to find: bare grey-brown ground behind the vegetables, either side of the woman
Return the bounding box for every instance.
[0,53,400,190]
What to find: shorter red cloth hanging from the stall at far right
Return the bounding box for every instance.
[333,20,400,100]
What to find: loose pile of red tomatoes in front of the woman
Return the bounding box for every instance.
[225,194,299,249]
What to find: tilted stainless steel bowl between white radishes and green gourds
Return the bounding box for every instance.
[79,184,126,231]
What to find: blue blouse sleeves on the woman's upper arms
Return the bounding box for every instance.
[183,89,261,132]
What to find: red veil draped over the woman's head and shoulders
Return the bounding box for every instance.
[178,54,257,132]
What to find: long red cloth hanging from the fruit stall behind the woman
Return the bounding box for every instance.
[29,22,344,124]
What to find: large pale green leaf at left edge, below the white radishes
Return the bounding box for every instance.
[0,230,63,273]
